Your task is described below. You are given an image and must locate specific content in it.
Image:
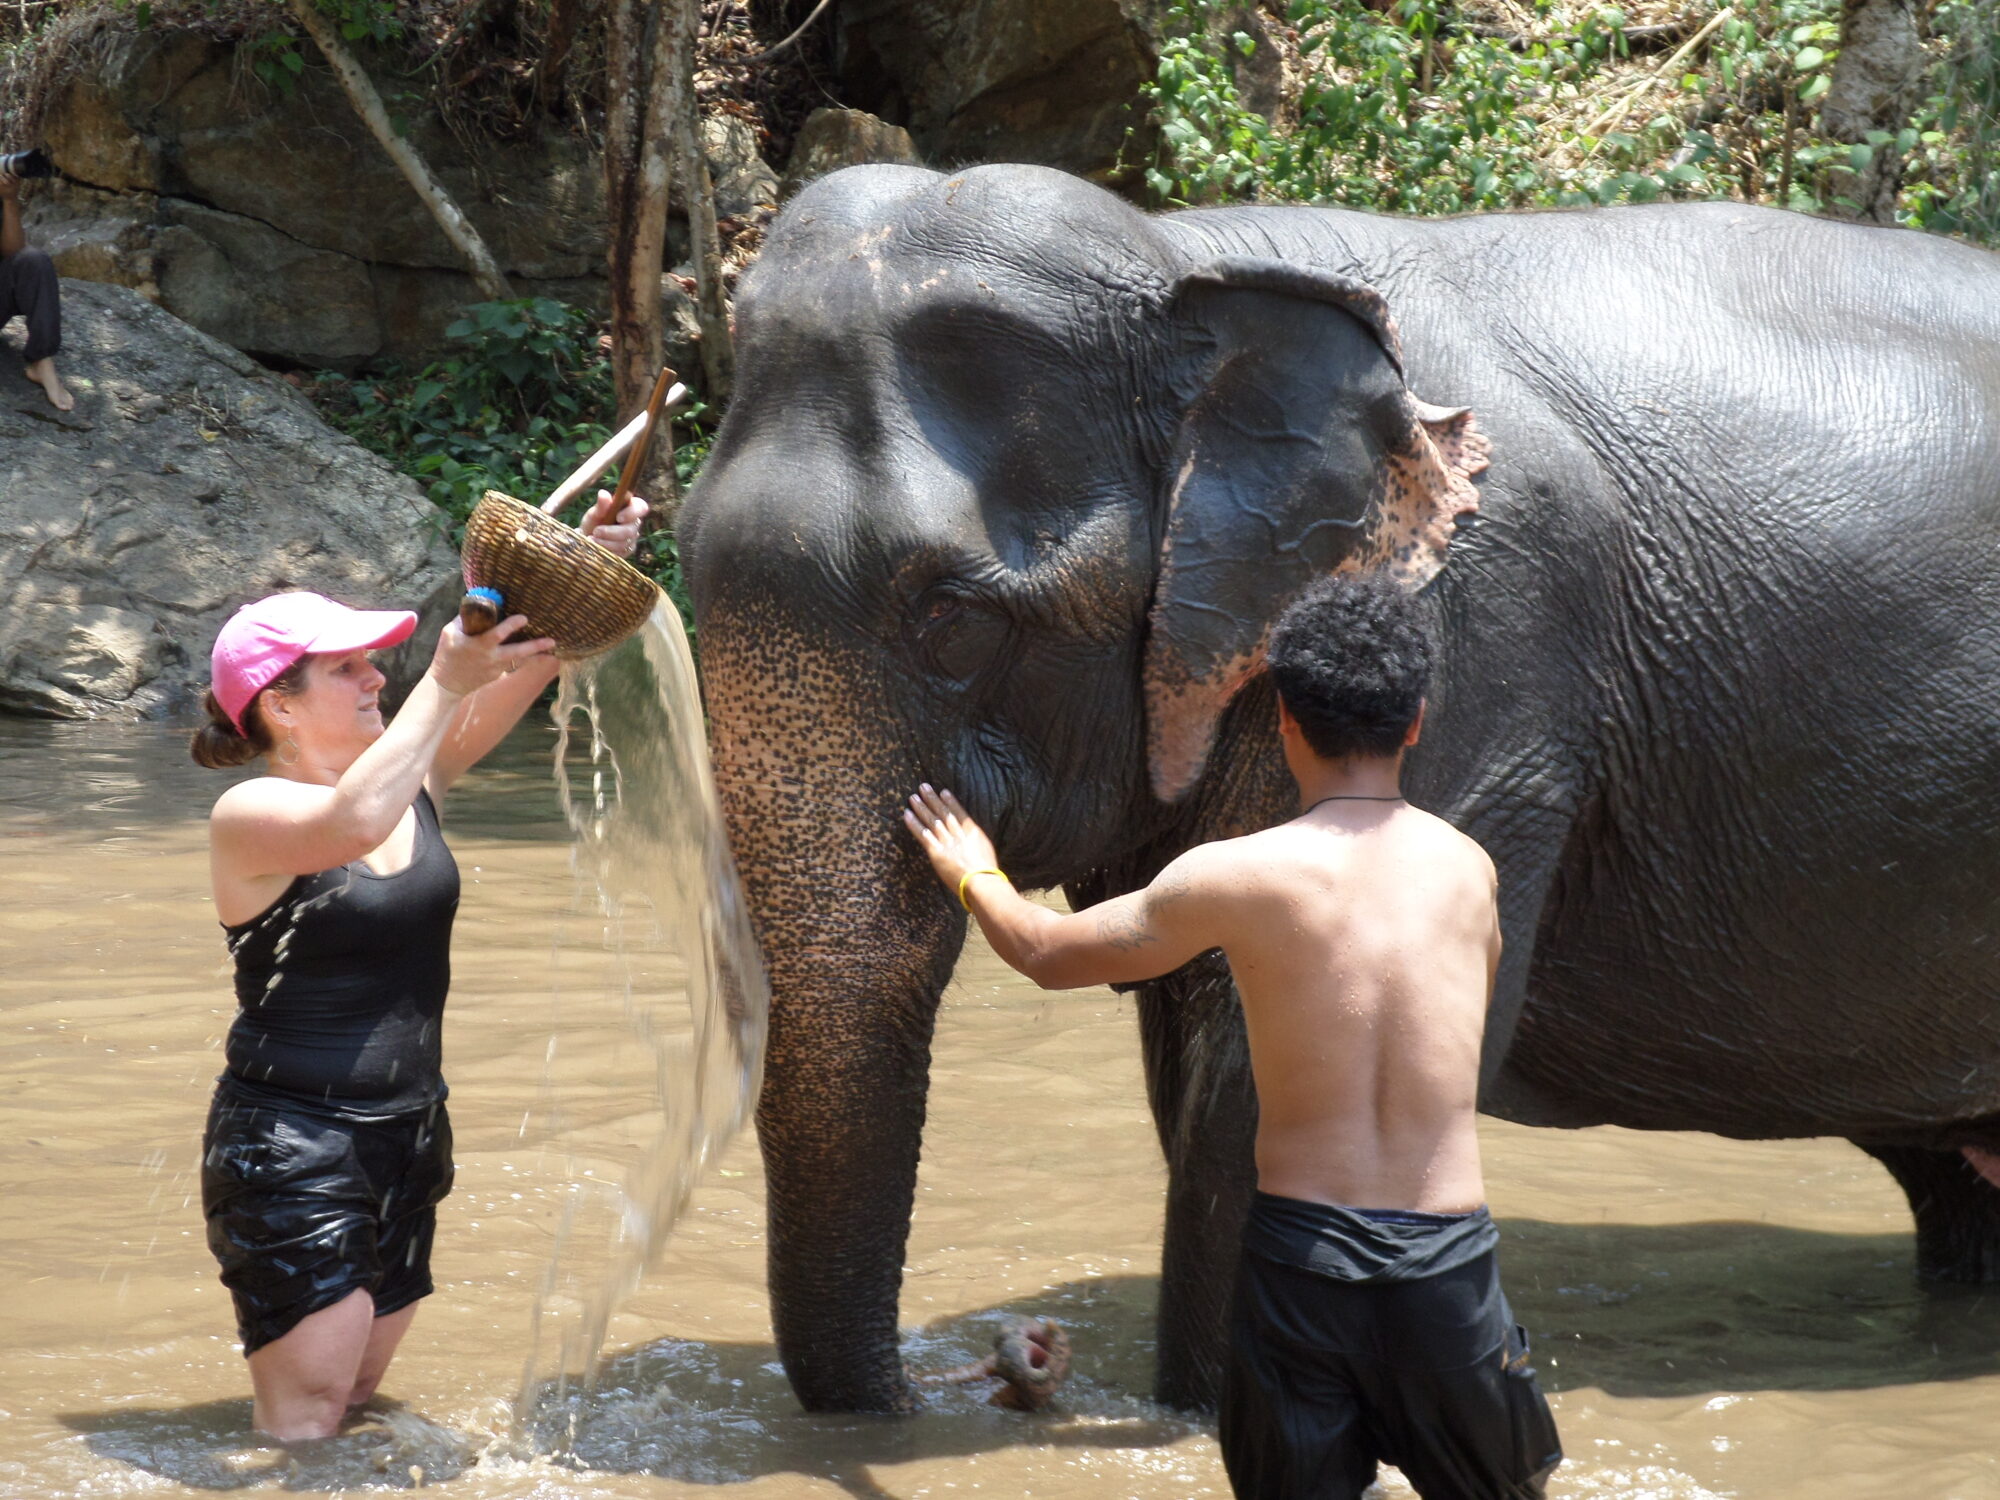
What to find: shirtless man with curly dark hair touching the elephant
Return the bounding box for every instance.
[904,576,1562,1500]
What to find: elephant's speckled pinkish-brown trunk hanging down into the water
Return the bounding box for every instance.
[702,622,964,1412]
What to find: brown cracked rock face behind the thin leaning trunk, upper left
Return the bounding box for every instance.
[26,30,778,368]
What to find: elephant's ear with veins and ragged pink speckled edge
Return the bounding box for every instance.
[1144,260,1488,802]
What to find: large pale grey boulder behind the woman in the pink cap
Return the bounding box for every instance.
[0,280,460,718]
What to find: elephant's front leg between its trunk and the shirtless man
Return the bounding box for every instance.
[1138,954,1256,1410]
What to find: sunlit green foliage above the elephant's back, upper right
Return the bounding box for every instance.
[1146,0,2000,238]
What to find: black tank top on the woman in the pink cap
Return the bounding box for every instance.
[222,792,458,1118]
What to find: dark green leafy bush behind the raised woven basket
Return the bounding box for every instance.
[308,298,708,618]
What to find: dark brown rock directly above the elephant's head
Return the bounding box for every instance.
[836,0,1164,180]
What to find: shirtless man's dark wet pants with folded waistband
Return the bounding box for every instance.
[1220,1192,1562,1500]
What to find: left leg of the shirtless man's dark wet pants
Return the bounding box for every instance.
[1218,1254,1376,1500]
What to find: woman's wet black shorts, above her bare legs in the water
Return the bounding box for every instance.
[202,1080,452,1354]
